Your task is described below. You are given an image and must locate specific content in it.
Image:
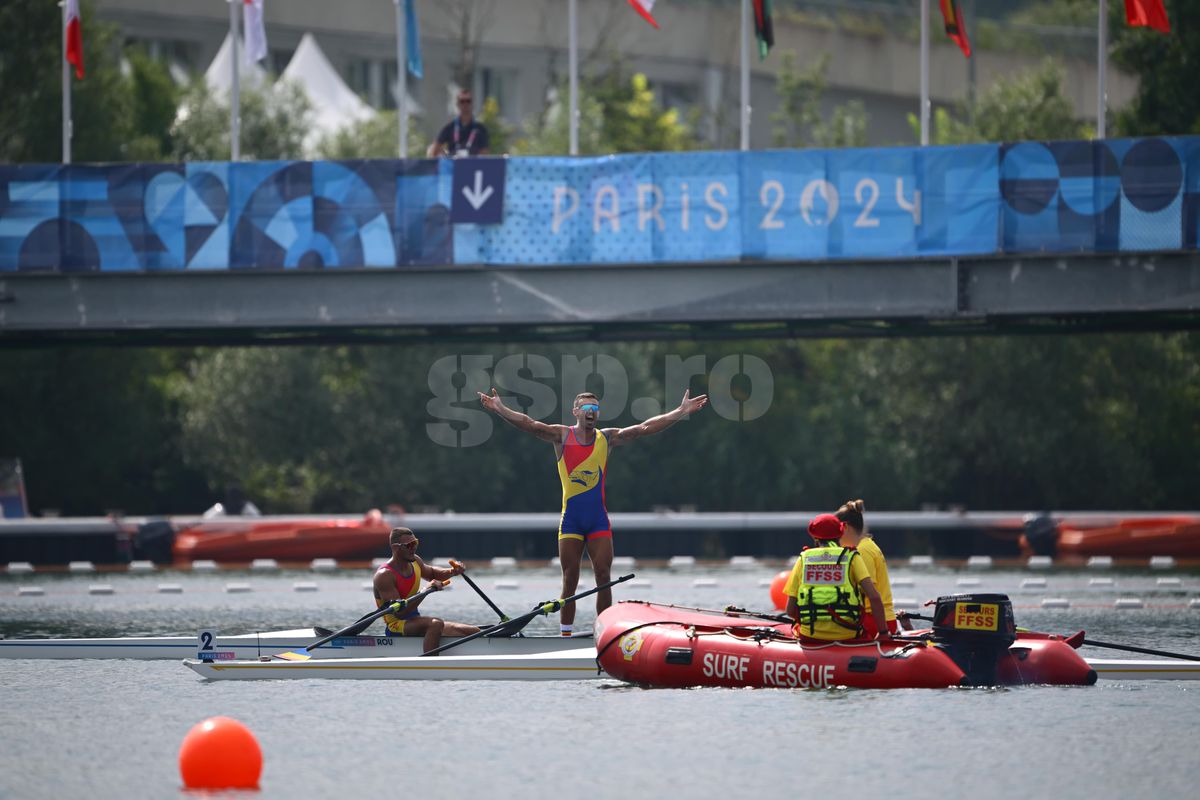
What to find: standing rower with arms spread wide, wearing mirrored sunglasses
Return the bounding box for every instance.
[478,389,708,636]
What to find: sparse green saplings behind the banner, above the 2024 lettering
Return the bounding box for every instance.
[770,53,866,148]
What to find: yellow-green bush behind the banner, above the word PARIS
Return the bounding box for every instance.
[511,66,698,156]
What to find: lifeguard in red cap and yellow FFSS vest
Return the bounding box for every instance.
[784,513,888,643]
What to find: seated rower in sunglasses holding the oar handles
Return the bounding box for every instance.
[373,528,479,652]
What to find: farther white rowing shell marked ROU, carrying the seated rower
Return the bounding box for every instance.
[0,628,592,662]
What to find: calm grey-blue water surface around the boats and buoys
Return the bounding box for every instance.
[0,565,1200,800]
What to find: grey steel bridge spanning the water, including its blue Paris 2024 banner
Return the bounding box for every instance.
[0,137,1200,345]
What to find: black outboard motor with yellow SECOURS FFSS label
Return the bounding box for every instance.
[934,595,1016,686]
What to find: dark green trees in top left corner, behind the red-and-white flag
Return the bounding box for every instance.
[0,0,169,163]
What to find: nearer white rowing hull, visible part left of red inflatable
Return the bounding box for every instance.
[184,642,600,680]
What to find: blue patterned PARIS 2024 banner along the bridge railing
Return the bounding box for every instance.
[0,137,1200,271]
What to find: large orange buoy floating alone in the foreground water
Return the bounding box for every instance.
[179,717,263,789]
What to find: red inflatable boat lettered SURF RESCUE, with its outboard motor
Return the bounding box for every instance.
[595,595,1096,688]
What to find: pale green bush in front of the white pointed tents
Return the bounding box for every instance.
[170,79,312,161]
